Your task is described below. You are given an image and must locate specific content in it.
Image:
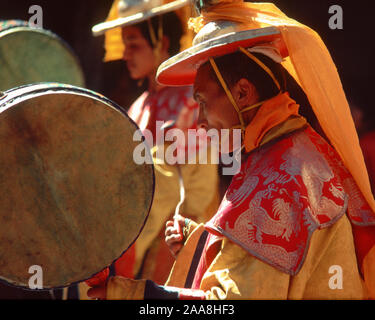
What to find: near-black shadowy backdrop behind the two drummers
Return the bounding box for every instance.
[0,0,375,131]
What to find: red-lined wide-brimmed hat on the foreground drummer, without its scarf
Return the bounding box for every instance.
[156,20,288,86]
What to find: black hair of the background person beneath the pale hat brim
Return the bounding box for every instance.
[135,12,183,56]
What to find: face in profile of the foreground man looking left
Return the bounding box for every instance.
[194,64,239,151]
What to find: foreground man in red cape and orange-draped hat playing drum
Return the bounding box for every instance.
[89,0,375,299]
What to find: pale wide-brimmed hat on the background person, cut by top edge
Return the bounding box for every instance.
[92,0,190,36]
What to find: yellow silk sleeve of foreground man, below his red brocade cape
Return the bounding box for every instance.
[200,215,367,300]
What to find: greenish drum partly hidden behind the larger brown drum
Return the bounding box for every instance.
[0,20,85,91]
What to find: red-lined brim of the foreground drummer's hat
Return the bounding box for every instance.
[156,27,288,86]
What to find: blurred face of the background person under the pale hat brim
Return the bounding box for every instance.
[122,27,156,79]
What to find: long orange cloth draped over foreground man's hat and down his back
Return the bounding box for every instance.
[189,0,375,215]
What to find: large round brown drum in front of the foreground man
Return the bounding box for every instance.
[0,84,154,289]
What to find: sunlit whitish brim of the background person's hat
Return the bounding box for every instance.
[91,0,190,36]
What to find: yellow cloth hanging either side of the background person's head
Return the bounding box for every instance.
[104,0,194,62]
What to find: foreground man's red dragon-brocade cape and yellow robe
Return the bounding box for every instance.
[167,127,375,299]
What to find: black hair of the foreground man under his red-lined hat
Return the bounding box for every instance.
[210,51,324,136]
